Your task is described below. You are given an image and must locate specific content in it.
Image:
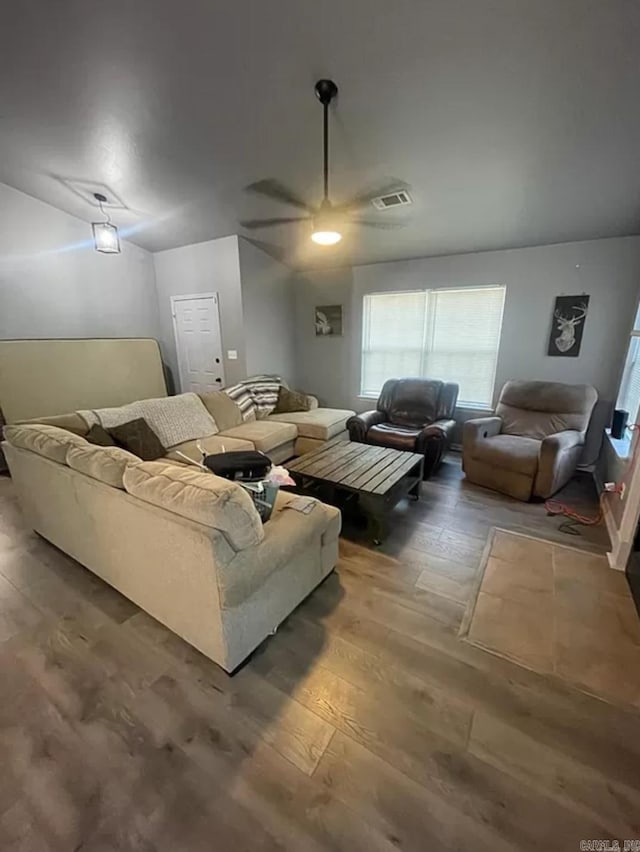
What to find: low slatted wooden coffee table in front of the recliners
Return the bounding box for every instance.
[287,439,424,544]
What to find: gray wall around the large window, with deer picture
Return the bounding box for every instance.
[296,237,640,417]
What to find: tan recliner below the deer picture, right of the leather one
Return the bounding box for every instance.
[462,381,598,500]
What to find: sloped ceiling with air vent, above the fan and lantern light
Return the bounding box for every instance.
[0,0,640,265]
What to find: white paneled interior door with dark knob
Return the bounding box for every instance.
[171,293,224,393]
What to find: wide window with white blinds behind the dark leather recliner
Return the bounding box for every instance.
[361,286,505,408]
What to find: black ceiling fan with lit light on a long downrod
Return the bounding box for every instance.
[240,80,406,246]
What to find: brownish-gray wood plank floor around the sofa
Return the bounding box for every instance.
[0,461,640,852]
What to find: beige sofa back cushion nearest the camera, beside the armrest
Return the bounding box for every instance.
[123,461,264,548]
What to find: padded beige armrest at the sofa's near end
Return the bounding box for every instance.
[218,491,341,609]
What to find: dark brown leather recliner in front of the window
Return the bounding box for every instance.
[347,379,458,479]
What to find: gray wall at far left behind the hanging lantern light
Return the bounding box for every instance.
[0,184,159,339]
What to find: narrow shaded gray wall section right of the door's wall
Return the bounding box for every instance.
[239,237,297,385]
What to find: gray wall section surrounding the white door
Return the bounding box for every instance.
[153,236,247,390]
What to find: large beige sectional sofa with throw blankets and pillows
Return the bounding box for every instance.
[3,392,352,672]
